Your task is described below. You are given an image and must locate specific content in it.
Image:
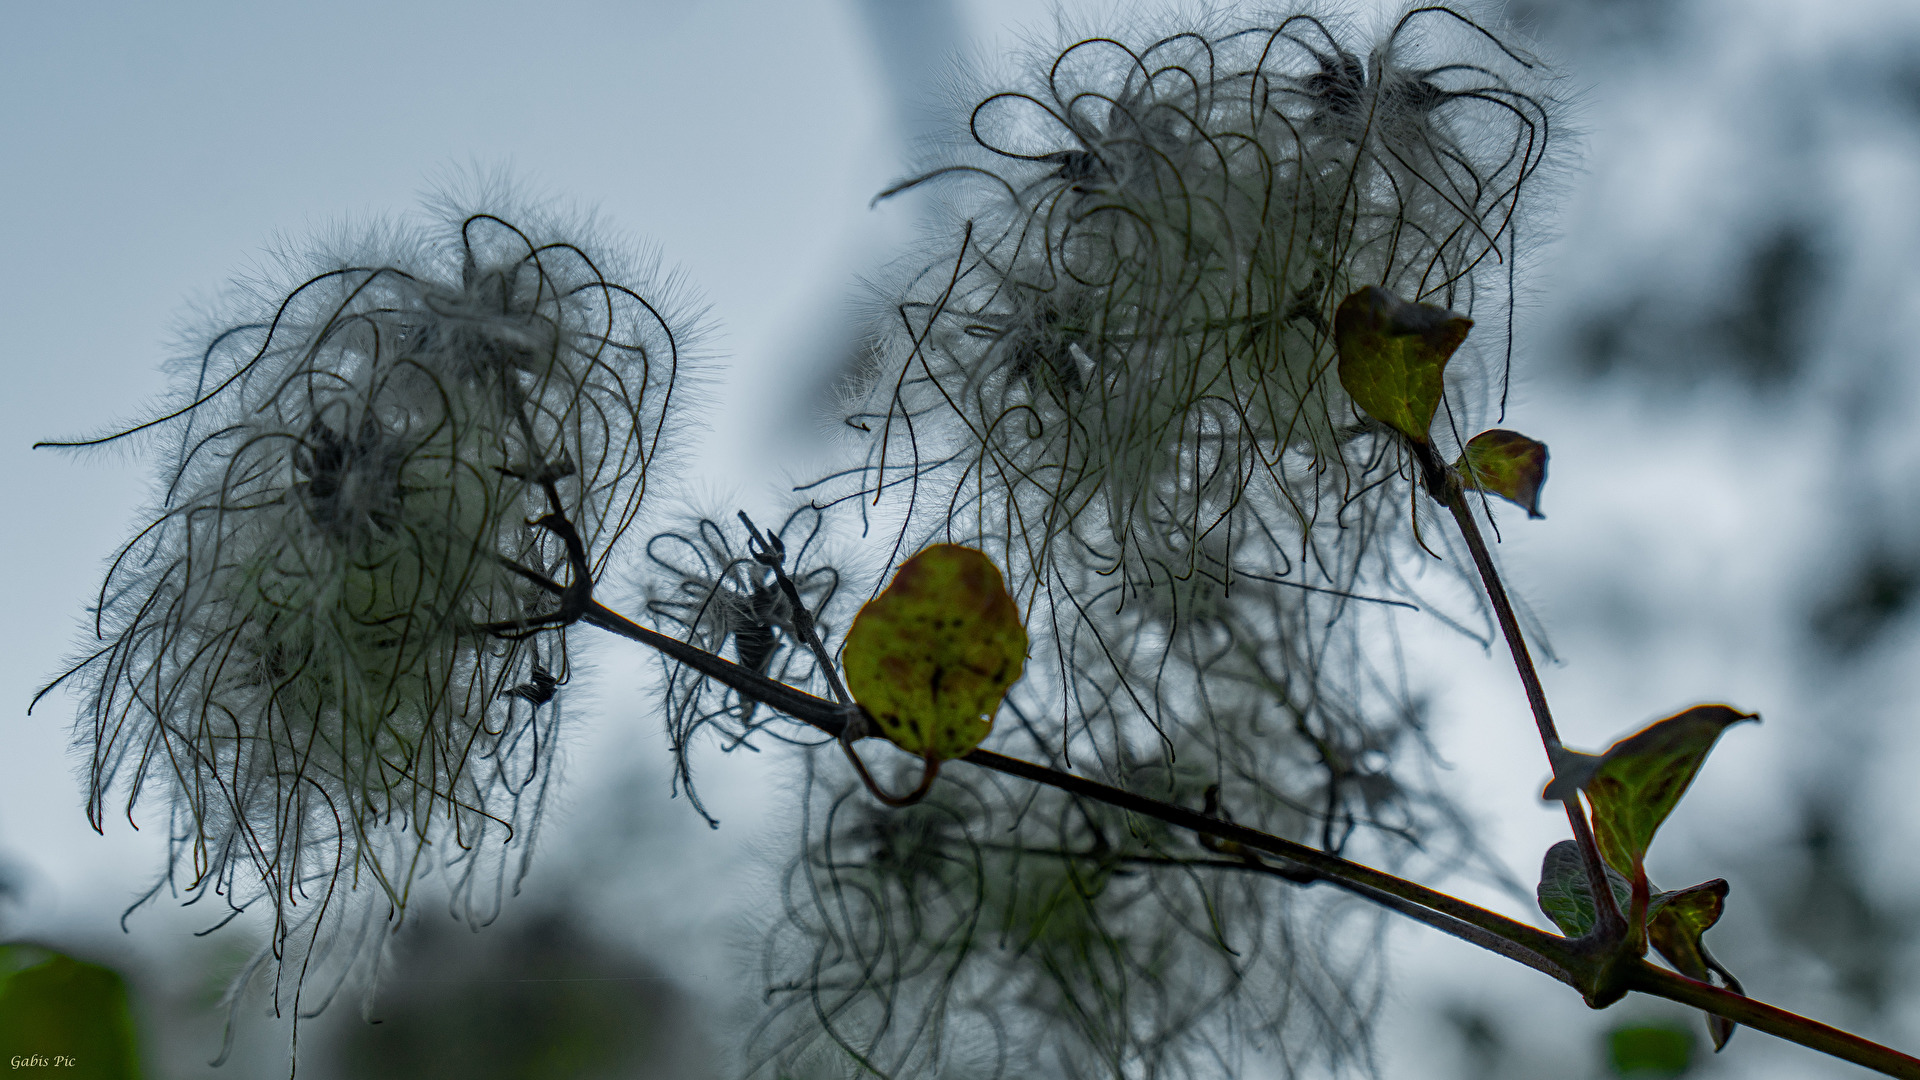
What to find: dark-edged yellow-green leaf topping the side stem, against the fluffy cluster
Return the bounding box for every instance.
[1332,284,1473,442]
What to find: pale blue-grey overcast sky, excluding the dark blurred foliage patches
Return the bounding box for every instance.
[0,0,1920,1078]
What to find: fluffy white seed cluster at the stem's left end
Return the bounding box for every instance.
[71,203,682,1006]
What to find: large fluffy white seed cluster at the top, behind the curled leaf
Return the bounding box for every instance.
[856,8,1551,582]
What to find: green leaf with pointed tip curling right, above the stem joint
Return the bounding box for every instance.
[1542,705,1759,880]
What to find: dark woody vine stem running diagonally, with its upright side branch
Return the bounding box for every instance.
[515,495,1920,1080]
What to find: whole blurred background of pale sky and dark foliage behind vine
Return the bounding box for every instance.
[0,0,1920,1080]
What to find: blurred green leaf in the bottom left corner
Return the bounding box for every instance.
[0,944,140,1080]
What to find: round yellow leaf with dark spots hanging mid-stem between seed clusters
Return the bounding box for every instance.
[841,544,1027,761]
